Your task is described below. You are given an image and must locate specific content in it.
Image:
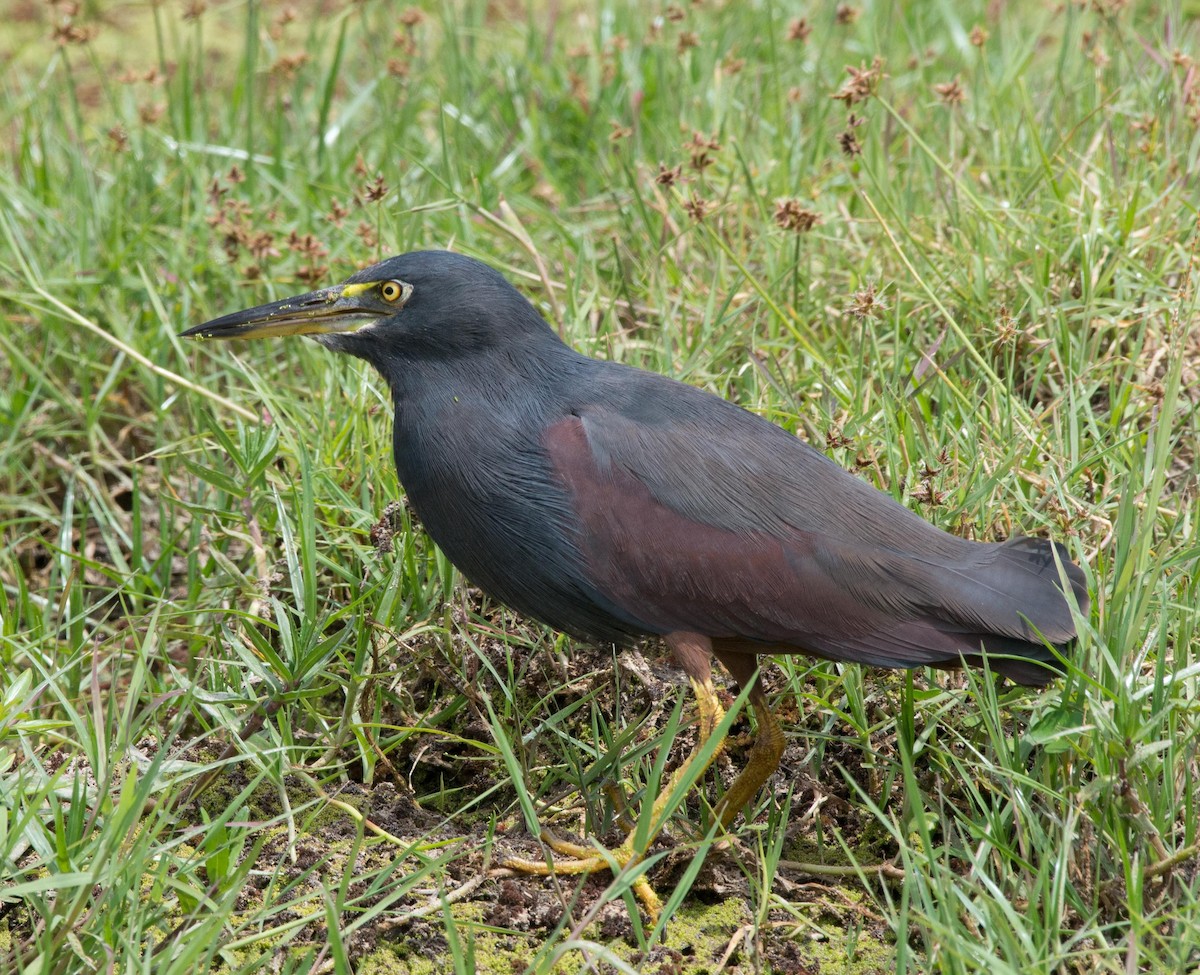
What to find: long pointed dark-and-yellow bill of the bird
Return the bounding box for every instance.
[180,283,385,339]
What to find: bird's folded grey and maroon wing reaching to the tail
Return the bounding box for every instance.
[545,389,1078,666]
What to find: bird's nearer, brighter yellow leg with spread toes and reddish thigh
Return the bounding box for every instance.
[502,633,720,919]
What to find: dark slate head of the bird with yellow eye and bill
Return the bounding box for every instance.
[182,251,558,378]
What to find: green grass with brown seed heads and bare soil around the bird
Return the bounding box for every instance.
[0,0,1200,975]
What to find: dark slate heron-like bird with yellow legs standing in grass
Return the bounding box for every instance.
[181,250,1088,916]
